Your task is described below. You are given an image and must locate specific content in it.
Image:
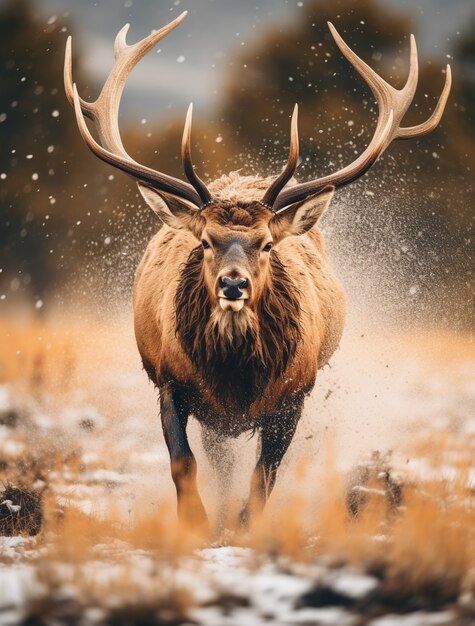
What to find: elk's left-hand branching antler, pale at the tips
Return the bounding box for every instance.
[64,11,212,206]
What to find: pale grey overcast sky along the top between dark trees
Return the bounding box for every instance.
[36,0,475,119]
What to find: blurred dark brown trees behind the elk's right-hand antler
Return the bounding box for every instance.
[223,0,475,324]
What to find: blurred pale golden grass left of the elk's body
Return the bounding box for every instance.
[0,317,140,415]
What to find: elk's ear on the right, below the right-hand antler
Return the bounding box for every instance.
[269,186,335,242]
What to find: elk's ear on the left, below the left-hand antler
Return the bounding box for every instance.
[137,183,205,239]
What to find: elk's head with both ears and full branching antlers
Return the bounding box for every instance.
[64,12,451,313]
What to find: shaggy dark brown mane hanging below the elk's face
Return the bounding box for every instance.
[175,246,301,410]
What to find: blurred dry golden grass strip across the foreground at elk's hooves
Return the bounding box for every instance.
[25,446,475,612]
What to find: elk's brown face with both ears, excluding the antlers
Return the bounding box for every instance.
[139,185,334,314]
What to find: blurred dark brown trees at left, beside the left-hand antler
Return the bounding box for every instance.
[0,0,160,306]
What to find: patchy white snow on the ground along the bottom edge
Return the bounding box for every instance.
[0,546,468,626]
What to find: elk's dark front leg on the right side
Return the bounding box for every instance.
[240,397,303,524]
